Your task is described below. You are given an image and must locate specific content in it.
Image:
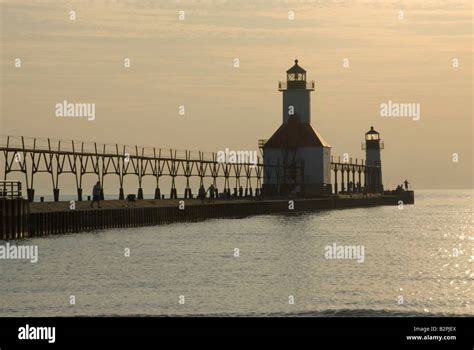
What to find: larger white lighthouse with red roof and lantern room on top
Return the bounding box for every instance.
[263,60,331,196]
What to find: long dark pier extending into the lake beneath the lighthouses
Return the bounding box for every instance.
[2,191,414,239]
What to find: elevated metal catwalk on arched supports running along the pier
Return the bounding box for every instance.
[0,136,380,201]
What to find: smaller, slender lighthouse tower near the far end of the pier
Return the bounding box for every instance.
[362,126,384,192]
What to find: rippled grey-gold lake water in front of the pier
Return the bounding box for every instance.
[0,190,474,316]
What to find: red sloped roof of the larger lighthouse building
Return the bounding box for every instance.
[263,115,331,148]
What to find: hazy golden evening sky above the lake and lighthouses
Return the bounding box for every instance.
[0,0,473,188]
